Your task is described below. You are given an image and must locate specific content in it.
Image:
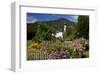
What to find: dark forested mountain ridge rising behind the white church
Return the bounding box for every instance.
[27,18,75,31]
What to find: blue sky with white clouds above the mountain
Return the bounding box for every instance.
[27,13,78,23]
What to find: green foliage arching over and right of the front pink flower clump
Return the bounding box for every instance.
[48,43,82,58]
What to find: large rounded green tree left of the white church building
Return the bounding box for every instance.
[35,23,53,42]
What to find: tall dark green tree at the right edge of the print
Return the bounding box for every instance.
[76,16,89,39]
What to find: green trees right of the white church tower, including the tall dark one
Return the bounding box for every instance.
[64,16,89,40]
